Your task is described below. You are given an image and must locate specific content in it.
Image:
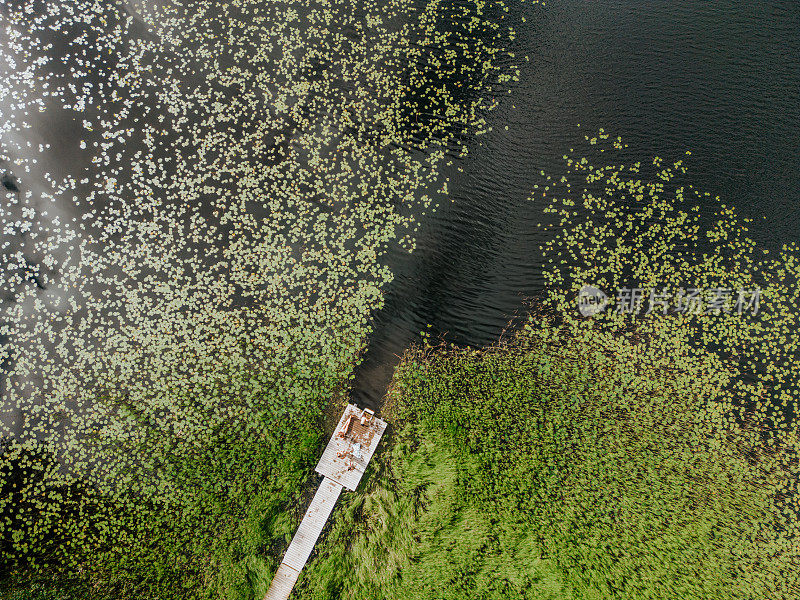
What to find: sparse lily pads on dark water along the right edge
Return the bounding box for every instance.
[534,130,800,559]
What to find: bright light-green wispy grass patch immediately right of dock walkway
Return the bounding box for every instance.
[299,426,566,600]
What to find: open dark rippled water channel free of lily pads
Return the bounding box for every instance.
[354,0,800,408]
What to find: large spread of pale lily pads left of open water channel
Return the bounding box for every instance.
[0,0,514,592]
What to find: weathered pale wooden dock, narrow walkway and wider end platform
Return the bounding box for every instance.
[264,404,386,600]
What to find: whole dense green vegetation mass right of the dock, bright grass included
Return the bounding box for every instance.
[295,316,800,600]
